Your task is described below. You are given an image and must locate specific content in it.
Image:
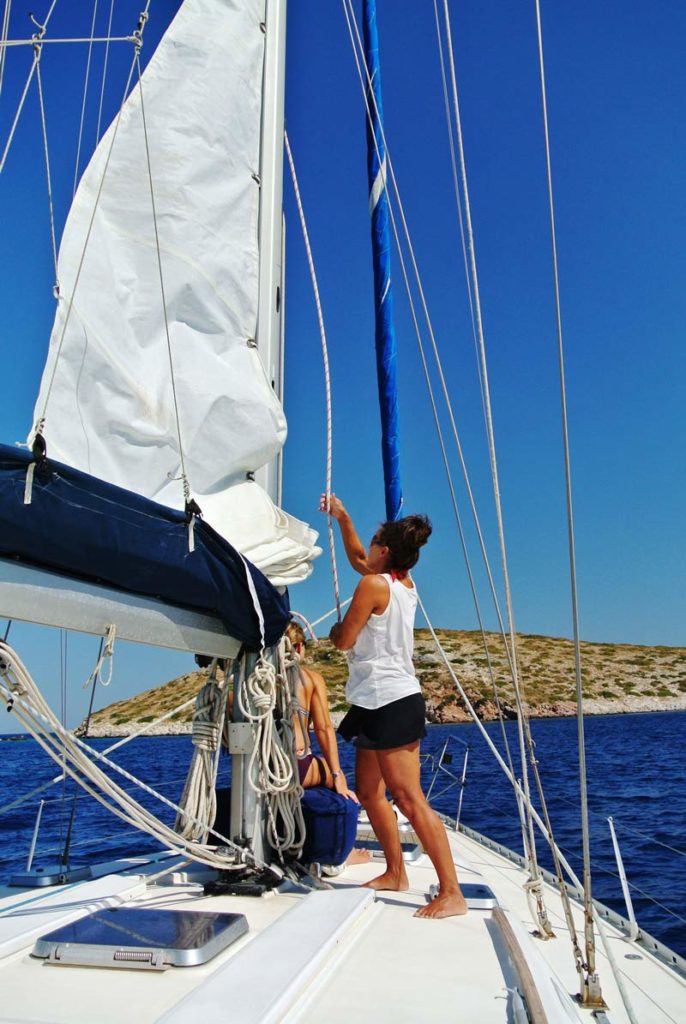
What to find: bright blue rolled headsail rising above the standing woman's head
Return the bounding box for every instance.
[362,0,402,519]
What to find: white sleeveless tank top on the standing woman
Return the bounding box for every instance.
[345,572,422,710]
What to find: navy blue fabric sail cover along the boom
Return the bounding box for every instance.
[0,444,289,653]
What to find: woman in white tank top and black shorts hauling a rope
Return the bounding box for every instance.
[319,495,467,918]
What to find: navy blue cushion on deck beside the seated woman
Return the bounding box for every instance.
[301,785,359,864]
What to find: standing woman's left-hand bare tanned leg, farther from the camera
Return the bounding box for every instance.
[355,748,409,892]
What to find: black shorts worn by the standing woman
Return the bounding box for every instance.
[338,693,426,751]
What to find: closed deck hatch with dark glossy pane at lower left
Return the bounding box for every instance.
[32,907,248,971]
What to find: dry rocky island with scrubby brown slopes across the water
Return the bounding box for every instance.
[77,630,686,736]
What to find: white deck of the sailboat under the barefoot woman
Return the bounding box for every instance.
[0,835,686,1024]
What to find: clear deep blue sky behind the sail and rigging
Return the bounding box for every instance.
[0,0,686,728]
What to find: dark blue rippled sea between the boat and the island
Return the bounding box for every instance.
[0,712,686,956]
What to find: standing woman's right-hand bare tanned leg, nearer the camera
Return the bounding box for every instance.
[377,741,467,918]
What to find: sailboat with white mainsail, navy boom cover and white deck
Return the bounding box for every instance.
[0,0,686,1024]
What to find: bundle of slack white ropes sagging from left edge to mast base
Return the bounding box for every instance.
[0,644,278,870]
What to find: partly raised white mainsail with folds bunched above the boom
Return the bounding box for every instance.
[35,0,318,584]
